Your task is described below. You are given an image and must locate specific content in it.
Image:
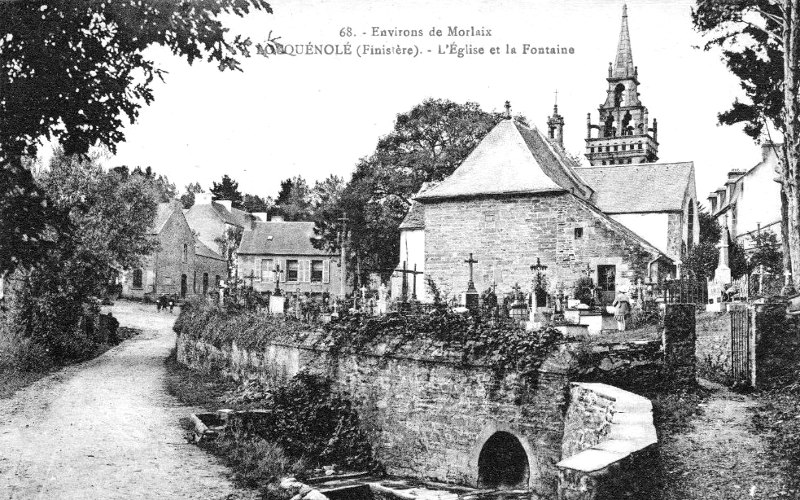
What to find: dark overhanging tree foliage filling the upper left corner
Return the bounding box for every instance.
[0,0,279,272]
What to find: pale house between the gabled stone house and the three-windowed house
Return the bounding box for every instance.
[186,193,256,254]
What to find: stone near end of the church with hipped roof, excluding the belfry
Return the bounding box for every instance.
[415,117,675,302]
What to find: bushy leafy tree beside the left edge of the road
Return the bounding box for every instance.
[9,153,163,363]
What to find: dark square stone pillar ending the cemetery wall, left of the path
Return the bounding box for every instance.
[662,304,697,385]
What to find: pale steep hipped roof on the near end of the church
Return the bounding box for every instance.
[415,119,593,201]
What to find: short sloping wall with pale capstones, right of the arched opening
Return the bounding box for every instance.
[556,383,658,500]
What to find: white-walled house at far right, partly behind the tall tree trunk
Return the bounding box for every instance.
[708,142,783,250]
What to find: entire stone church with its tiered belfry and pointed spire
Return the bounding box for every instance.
[393,6,699,303]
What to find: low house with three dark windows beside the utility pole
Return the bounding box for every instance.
[237,216,342,296]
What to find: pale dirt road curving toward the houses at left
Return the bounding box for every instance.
[0,302,253,499]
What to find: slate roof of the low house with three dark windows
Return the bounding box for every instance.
[238,222,331,256]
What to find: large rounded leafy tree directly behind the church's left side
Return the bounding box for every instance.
[317,99,525,286]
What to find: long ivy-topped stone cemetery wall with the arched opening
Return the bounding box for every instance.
[177,305,694,498]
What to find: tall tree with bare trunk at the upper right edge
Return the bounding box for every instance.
[692,0,800,283]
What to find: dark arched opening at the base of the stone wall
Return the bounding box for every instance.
[478,431,530,488]
